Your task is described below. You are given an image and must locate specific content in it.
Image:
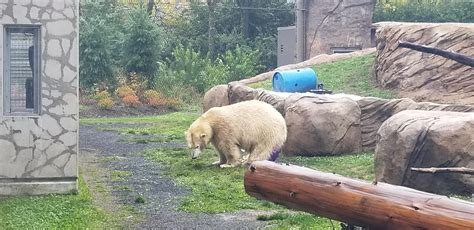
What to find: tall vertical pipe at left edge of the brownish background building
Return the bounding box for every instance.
[296,0,306,62]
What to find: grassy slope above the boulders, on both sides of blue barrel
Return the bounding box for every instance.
[251,54,394,98]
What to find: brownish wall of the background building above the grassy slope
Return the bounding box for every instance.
[305,0,375,59]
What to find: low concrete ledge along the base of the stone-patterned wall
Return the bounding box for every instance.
[0,180,78,196]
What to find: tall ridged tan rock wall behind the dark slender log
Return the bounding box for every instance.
[375,22,474,105]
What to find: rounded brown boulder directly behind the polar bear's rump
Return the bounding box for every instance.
[283,94,362,156]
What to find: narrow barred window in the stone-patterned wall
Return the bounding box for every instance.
[3,25,41,115]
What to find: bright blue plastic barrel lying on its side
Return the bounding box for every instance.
[272,68,318,93]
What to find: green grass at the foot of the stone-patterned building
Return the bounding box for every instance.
[0,176,112,229]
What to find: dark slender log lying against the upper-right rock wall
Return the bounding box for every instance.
[398,42,474,67]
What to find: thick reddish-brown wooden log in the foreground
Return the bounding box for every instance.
[244,161,474,229]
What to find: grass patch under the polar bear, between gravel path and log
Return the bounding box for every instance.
[145,148,276,213]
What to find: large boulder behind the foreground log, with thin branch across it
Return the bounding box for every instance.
[375,110,474,194]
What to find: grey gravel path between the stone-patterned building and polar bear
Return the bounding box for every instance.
[80,124,266,229]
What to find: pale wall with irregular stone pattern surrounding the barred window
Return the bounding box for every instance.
[0,0,79,194]
